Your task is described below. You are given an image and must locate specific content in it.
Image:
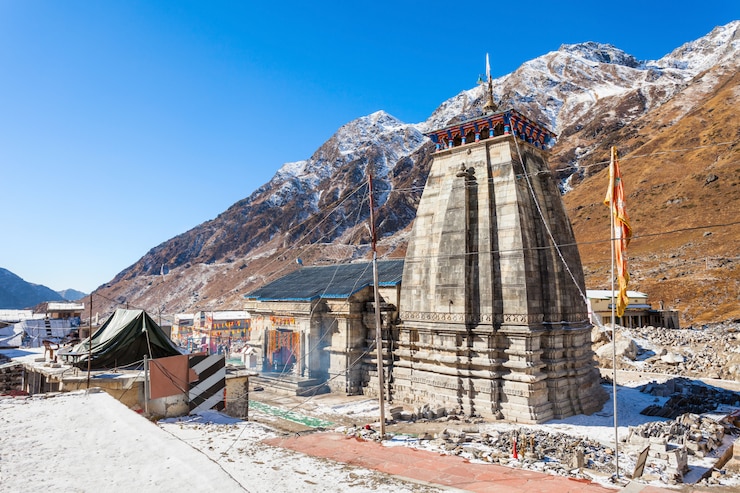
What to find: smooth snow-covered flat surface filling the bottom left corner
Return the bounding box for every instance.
[0,392,247,492]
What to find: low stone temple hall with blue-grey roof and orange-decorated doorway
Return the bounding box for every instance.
[245,260,403,395]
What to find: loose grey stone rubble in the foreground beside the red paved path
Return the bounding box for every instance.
[343,413,738,485]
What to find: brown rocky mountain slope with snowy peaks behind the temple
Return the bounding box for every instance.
[95,21,740,324]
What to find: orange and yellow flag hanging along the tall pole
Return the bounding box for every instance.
[604,147,632,317]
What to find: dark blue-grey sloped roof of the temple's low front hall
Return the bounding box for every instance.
[245,260,403,301]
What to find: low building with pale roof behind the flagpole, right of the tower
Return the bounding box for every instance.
[586,289,680,329]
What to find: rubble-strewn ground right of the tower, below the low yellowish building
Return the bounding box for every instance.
[591,322,740,380]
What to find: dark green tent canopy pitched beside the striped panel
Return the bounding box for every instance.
[72,308,182,370]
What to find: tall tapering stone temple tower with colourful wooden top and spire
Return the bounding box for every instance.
[392,58,606,423]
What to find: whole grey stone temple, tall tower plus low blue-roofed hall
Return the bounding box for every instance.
[245,77,607,423]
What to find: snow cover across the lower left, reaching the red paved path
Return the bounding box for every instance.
[0,389,439,493]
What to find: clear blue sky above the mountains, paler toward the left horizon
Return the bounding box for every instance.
[0,0,740,292]
